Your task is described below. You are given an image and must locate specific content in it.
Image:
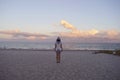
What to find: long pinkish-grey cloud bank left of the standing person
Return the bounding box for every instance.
[0,29,49,40]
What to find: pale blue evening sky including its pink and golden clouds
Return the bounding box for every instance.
[0,0,120,42]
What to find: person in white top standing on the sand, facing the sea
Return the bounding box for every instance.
[55,37,63,63]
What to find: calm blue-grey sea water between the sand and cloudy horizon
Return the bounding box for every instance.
[0,42,120,50]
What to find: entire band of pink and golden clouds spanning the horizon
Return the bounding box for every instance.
[0,20,120,42]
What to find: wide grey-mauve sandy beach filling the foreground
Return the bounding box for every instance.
[0,49,120,80]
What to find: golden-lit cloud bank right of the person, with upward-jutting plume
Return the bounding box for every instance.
[59,20,120,41]
